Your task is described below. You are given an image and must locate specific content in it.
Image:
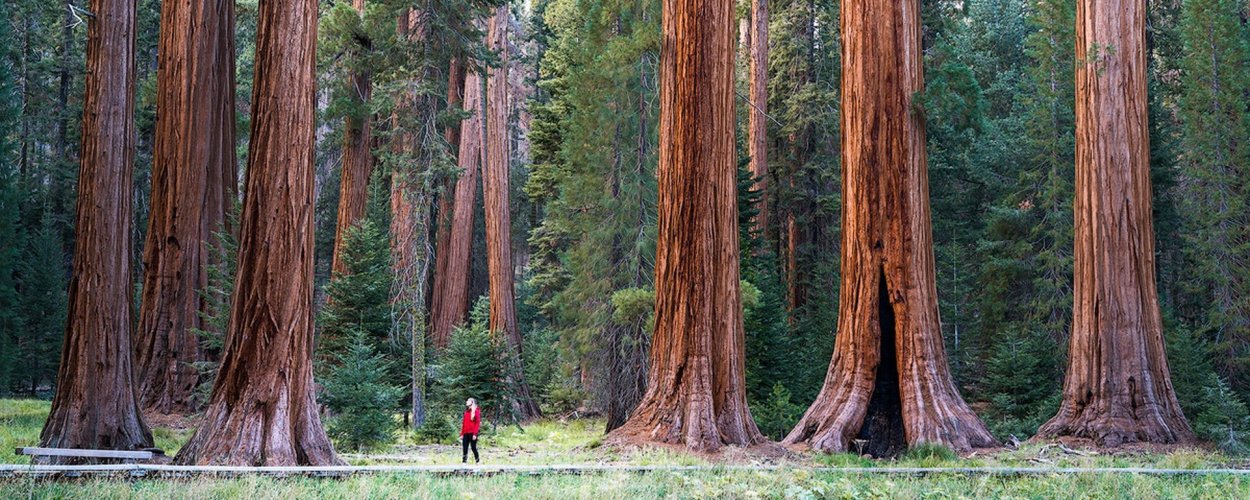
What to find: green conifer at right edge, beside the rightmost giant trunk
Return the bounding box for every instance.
[1178,0,1250,391]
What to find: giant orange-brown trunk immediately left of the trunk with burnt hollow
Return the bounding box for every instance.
[609,0,764,451]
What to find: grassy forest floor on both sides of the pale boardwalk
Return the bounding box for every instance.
[0,400,1250,500]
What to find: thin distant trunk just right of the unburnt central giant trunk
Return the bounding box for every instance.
[748,0,769,235]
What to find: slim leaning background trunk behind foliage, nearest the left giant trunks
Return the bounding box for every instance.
[330,0,374,274]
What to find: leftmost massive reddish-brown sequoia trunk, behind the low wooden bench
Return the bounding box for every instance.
[39,0,153,457]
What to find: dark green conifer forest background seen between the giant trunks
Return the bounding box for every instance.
[0,0,1250,448]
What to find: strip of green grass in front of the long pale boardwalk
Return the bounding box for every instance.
[0,469,1250,500]
